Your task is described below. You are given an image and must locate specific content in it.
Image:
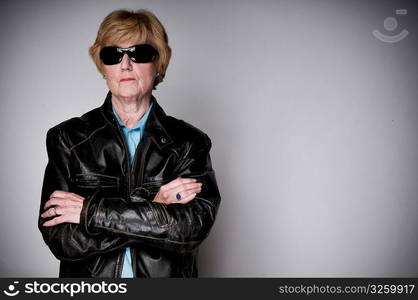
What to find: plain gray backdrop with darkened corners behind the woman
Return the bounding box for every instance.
[0,0,418,277]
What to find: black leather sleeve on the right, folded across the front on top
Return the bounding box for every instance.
[80,133,221,252]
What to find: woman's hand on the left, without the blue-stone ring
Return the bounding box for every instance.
[41,190,85,227]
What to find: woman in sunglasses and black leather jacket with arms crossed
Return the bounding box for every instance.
[39,10,220,277]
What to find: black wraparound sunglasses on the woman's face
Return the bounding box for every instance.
[100,44,158,65]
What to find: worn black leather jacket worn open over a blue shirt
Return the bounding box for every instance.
[38,92,220,277]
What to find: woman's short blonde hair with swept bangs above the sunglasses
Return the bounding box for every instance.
[89,9,171,88]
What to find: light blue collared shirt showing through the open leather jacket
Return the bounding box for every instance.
[113,103,153,278]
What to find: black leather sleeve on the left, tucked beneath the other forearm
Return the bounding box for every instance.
[38,127,130,260]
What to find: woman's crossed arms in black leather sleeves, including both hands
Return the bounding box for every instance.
[38,127,220,260]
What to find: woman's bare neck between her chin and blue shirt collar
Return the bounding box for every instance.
[112,94,151,129]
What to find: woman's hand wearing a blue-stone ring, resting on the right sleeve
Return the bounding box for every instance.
[152,177,202,204]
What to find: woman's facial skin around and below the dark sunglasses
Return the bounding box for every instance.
[103,43,156,99]
